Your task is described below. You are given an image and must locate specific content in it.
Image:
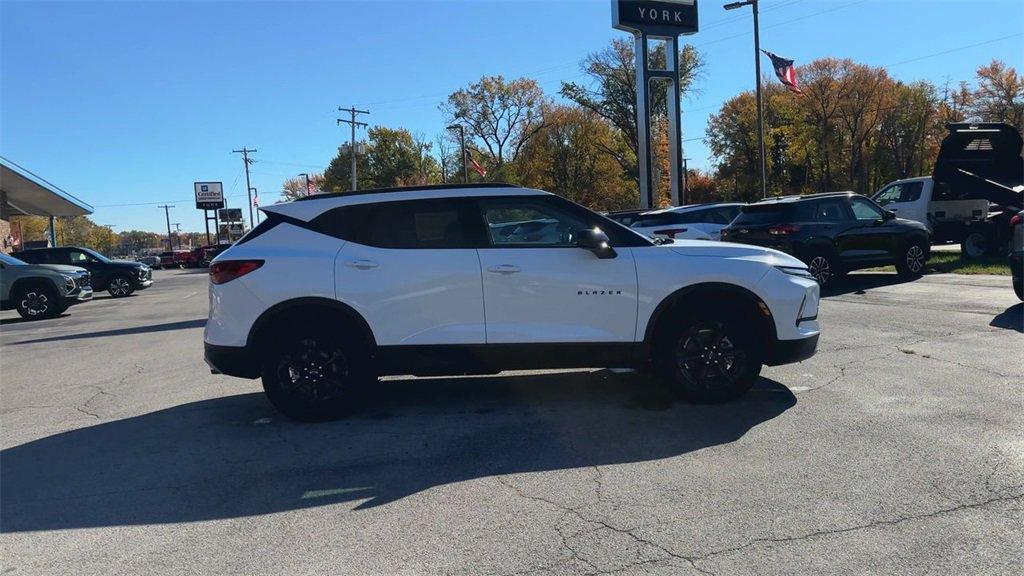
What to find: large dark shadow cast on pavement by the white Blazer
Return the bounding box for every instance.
[0,371,797,532]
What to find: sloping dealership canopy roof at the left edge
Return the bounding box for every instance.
[0,157,92,216]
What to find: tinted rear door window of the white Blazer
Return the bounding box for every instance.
[355,199,479,249]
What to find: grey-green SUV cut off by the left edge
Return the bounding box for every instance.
[0,252,92,320]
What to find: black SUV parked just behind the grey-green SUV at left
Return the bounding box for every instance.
[11,246,153,298]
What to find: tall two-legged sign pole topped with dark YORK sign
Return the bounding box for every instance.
[611,0,698,209]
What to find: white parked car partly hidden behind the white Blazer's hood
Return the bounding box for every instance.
[630,203,743,240]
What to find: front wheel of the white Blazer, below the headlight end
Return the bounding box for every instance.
[654,306,762,404]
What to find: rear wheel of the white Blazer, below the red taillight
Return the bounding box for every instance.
[262,323,375,422]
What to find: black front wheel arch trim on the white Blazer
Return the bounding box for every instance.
[643,282,777,351]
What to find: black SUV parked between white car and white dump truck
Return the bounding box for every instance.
[722,192,931,286]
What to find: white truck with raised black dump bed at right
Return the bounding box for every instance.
[871,123,1024,258]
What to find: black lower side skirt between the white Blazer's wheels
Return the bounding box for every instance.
[375,342,647,376]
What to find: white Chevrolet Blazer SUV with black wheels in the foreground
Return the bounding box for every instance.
[205,184,818,420]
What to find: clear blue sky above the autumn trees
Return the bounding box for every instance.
[0,0,1024,231]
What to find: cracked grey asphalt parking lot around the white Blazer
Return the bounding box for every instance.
[0,271,1024,575]
